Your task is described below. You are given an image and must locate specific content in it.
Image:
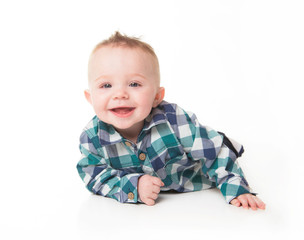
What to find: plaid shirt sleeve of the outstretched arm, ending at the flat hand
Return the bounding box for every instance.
[179,108,255,203]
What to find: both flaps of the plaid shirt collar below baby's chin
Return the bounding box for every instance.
[98,102,167,146]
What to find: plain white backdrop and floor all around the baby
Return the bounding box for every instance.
[0,0,304,239]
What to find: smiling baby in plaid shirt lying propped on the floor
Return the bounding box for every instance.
[77,32,265,210]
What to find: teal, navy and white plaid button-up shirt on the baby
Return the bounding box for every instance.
[77,101,251,203]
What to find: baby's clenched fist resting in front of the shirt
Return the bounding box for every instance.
[138,175,165,206]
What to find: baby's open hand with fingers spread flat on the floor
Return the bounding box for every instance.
[230,193,266,210]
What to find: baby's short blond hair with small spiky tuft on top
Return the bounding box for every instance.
[91,31,160,81]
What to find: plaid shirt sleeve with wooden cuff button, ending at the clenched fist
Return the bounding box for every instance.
[77,131,142,203]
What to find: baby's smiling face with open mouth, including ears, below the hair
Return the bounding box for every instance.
[86,46,162,132]
